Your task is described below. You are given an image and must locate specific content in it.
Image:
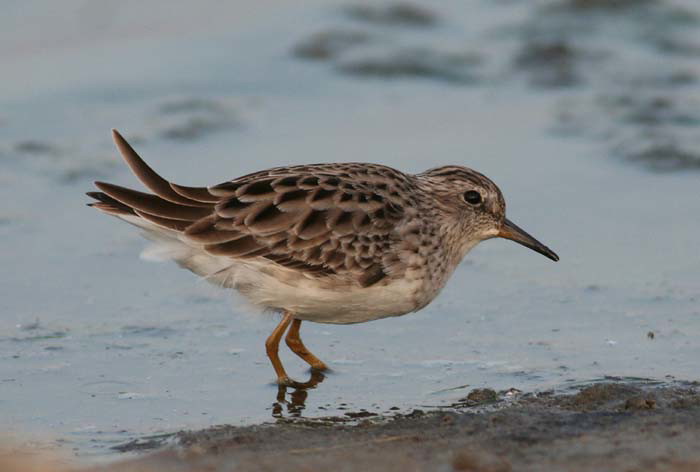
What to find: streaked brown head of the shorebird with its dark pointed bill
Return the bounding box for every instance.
[418,166,559,261]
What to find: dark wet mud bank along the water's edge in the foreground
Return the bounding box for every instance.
[102,382,700,471]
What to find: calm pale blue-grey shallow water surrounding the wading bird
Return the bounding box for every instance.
[0,0,700,457]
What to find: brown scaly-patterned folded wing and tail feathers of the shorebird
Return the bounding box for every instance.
[89,127,410,286]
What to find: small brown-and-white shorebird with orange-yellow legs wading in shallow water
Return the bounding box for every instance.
[88,130,559,385]
